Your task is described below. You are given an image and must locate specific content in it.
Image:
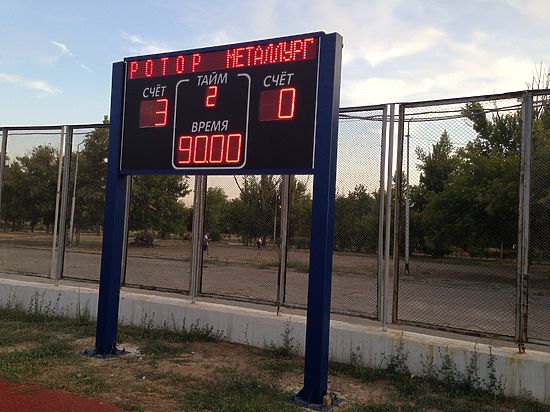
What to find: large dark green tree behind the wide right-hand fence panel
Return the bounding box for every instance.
[411,103,520,257]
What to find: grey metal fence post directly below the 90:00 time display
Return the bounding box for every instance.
[189,175,207,303]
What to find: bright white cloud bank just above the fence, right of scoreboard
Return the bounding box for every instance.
[342,45,533,106]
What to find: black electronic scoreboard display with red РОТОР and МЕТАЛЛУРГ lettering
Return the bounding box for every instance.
[120,33,324,174]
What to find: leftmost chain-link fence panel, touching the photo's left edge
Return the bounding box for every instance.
[0,127,64,277]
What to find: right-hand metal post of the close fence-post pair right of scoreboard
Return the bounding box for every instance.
[394,105,405,323]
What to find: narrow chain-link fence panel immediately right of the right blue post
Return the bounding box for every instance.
[332,107,385,318]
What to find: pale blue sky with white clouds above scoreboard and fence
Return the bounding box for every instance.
[0,0,550,126]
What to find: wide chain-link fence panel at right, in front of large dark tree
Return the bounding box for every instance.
[393,93,540,337]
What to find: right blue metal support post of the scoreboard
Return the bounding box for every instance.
[296,33,343,405]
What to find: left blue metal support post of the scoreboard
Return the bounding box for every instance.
[94,62,128,356]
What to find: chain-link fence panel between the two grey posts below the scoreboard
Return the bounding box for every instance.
[200,175,281,303]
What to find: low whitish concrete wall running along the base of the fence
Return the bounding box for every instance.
[0,279,550,403]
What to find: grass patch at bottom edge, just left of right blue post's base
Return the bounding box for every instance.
[182,373,302,412]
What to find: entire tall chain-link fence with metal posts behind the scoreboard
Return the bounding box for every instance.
[0,90,550,346]
